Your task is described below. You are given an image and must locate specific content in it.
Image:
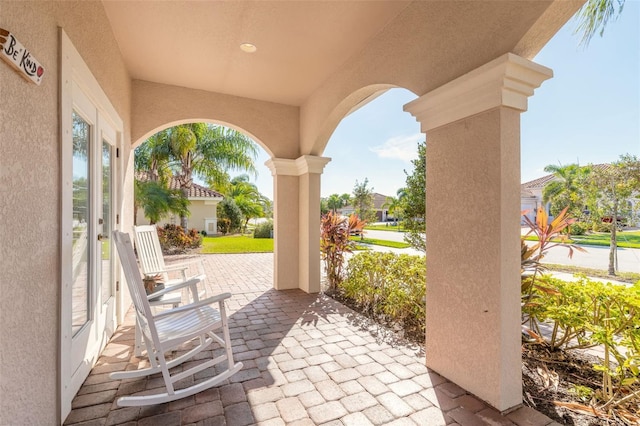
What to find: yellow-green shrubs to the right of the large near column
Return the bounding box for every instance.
[523,276,640,400]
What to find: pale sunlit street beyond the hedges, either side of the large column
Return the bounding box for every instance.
[365,230,640,273]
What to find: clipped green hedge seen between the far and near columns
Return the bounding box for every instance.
[339,252,426,336]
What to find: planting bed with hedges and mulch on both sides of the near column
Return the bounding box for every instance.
[327,253,640,426]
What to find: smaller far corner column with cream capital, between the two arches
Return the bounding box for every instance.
[265,155,331,293]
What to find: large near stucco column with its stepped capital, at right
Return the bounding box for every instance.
[405,54,552,411]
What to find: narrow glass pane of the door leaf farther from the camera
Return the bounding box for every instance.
[100,141,113,303]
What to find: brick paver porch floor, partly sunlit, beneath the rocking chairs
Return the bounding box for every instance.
[65,254,557,426]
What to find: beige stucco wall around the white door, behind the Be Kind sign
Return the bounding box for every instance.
[0,1,131,425]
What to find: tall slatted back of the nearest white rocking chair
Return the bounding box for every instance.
[113,231,157,342]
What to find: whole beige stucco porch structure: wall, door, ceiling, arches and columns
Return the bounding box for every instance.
[0,0,582,425]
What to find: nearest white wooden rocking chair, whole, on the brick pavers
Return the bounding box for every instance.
[109,231,242,407]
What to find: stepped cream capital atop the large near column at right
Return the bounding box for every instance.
[404,53,553,132]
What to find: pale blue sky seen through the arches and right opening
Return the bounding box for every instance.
[248,0,640,198]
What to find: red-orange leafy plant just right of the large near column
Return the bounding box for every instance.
[521,207,586,316]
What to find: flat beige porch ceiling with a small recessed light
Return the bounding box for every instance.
[104,1,409,105]
